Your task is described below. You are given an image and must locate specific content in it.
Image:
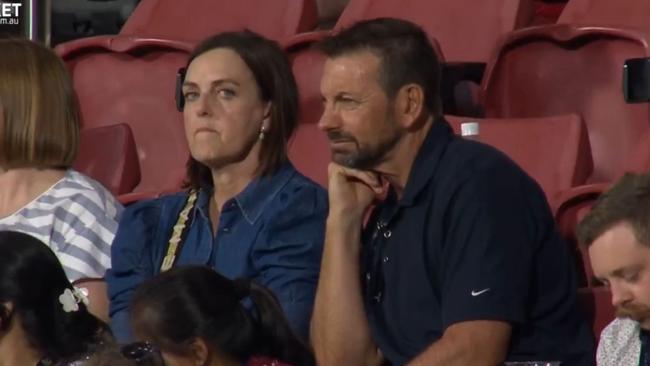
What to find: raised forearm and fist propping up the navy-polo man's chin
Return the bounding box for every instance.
[311,163,382,366]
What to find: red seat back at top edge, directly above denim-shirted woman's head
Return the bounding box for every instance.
[120,0,318,42]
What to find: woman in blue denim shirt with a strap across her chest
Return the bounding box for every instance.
[106,31,327,342]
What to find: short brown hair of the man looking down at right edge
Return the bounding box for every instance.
[577,173,650,247]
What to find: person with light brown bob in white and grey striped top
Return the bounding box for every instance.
[0,39,122,317]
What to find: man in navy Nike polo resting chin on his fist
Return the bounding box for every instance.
[311,19,593,366]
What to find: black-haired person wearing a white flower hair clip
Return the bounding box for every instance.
[0,231,110,366]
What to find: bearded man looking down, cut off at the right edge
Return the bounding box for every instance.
[578,174,650,366]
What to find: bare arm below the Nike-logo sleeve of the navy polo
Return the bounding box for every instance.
[408,320,511,366]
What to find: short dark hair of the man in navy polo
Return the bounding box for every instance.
[319,18,442,116]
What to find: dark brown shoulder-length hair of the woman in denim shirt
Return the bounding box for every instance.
[182,30,298,189]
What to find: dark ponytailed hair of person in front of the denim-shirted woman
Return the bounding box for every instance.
[131,266,315,366]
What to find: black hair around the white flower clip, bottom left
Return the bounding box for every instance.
[0,231,108,361]
